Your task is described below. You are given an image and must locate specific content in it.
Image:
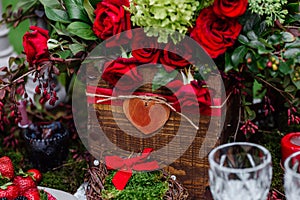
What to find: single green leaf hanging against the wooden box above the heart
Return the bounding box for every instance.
[152,66,178,91]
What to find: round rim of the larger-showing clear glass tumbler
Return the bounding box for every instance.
[208,142,272,173]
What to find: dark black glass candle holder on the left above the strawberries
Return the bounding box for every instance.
[23,122,69,172]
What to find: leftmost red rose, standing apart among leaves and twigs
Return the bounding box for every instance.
[23,26,50,66]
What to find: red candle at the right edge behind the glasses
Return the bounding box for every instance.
[281,132,300,166]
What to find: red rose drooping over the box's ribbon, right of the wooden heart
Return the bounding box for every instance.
[173,81,211,115]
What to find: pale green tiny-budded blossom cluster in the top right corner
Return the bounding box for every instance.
[249,0,288,26]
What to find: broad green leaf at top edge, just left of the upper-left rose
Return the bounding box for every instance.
[64,0,89,22]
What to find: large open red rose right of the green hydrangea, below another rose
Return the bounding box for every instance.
[191,7,242,58]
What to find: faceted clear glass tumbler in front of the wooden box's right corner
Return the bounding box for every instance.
[208,142,272,200]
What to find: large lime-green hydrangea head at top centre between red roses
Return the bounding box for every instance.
[129,0,200,43]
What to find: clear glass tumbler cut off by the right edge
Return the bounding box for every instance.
[284,151,300,200]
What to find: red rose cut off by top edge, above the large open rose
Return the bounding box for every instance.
[213,0,248,18]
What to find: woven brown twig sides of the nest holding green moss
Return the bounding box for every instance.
[86,159,188,200]
